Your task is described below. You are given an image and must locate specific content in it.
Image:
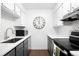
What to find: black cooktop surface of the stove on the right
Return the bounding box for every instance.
[53,38,79,51]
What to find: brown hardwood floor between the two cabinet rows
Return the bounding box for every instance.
[29,50,49,56]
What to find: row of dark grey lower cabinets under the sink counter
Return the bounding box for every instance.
[4,37,31,56]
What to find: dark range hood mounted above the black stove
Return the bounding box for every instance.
[61,7,79,21]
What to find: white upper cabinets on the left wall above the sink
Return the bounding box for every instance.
[1,3,20,19]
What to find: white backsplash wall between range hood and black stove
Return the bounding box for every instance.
[54,20,79,37]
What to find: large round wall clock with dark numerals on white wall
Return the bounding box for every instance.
[33,16,46,29]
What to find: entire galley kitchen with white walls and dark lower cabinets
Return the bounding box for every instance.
[0,3,79,57]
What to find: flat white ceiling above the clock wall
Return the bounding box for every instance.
[22,3,57,9]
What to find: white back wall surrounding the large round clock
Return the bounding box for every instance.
[22,9,53,49]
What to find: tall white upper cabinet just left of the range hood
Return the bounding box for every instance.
[53,4,63,27]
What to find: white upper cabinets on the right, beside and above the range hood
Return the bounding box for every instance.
[53,3,79,27]
